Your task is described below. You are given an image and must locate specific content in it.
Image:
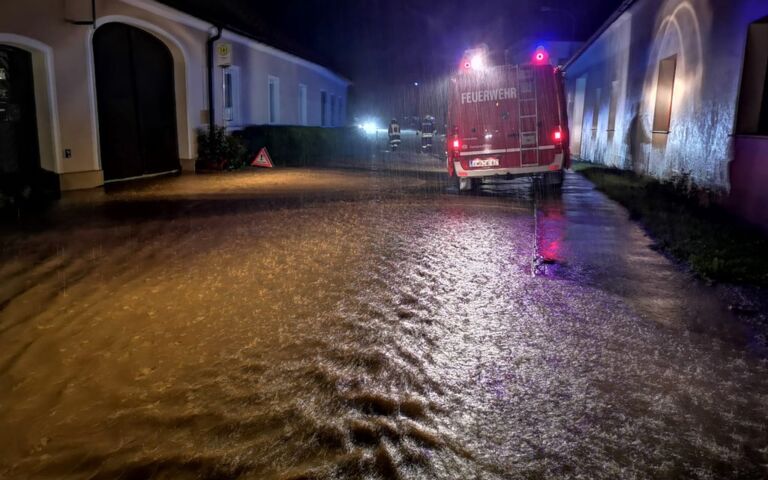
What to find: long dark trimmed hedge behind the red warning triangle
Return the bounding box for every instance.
[235,125,370,166]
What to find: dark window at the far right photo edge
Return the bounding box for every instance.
[736,17,768,135]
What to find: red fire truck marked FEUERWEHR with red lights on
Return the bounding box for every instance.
[446,50,570,191]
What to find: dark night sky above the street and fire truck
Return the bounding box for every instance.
[162,0,621,114]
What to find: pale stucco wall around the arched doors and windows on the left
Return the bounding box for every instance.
[0,0,348,189]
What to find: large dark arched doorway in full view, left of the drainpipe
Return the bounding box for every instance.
[93,23,180,181]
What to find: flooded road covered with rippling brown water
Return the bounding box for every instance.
[0,156,768,479]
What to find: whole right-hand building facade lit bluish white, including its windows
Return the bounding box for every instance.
[565,0,768,226]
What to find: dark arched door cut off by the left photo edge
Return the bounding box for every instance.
[0,45,40,178]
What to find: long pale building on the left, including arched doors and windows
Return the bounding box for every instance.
[0,0,349,190]
